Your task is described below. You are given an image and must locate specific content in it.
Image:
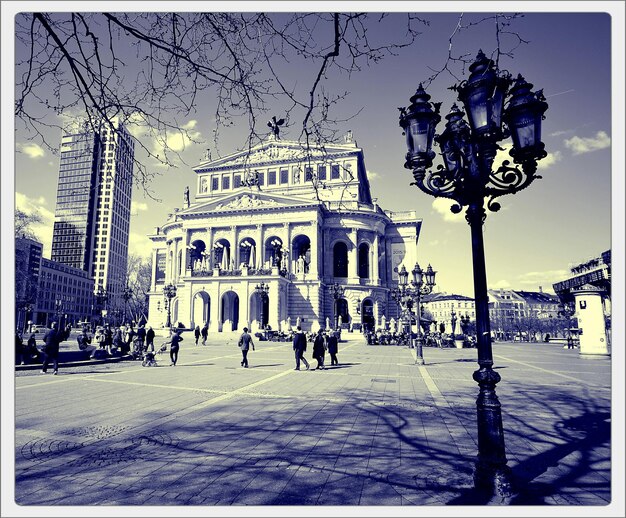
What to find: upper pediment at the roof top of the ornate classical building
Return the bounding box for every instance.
[193,139,360,173]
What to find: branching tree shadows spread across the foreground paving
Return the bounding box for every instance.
[16,370,610,505]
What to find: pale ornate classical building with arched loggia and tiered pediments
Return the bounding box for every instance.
[149,136,421,332]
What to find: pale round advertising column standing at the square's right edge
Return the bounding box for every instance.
[572,286,611,358]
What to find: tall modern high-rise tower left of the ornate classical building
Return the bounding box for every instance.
[51,121,134,303]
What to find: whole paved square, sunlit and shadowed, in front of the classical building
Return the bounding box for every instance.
[15,335,611,506]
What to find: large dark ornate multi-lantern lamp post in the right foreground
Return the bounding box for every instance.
[400,51,548,496]
